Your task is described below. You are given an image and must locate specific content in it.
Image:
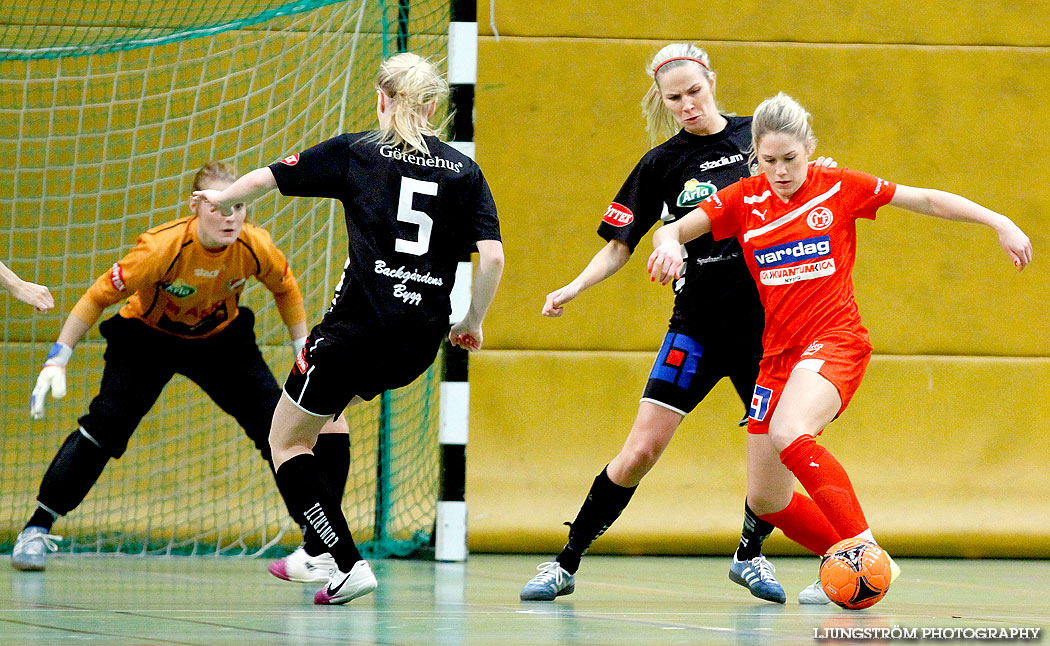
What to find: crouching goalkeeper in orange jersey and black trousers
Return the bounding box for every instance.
[12,162,350,581]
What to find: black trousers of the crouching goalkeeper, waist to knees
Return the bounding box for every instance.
[78,308,280,458]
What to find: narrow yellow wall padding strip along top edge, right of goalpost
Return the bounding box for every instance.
[478,0,1050,46]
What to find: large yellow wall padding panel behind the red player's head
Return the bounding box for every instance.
[476,37,1050,356]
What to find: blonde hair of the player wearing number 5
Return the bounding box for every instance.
[371,51,452,155]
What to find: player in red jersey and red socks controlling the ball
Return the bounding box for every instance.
[649,93,1032,600]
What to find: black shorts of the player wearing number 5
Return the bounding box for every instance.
[285,326,447,417]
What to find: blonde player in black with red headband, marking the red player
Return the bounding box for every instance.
[521,43,834,603]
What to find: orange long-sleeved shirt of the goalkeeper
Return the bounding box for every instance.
[74,215,307,338]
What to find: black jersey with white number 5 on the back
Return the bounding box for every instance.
[270,132,500,333]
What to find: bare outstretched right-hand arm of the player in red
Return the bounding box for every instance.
[889,185,1032,271]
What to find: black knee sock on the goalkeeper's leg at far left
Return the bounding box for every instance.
[26,430,109,530]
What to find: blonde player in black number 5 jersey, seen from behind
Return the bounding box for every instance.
[196,54,503,604]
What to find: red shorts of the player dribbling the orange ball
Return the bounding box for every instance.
[748,331,872,434]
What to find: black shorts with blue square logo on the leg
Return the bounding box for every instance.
[642,330,762,415]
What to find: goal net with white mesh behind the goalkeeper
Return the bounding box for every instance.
[0,0,449,557]
